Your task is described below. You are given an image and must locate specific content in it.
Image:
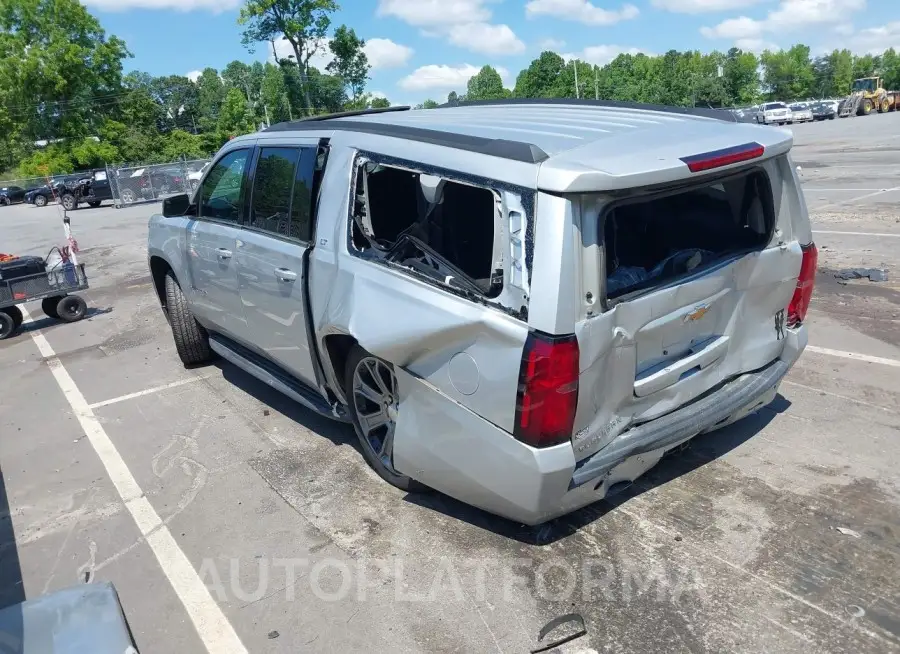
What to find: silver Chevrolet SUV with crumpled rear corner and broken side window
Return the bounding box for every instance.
[149,101,816,524]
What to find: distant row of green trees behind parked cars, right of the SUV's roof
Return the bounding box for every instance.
[418,44,900,109]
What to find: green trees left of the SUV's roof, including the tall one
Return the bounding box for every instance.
[0,0,389,178]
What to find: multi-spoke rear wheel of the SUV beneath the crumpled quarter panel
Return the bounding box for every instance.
[344,345,427,492]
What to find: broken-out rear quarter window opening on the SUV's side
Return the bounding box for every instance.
[352,162,503,297]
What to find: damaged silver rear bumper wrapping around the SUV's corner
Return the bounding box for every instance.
[414,326,807,525]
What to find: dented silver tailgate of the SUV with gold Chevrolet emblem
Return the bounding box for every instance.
[573,156,802,460]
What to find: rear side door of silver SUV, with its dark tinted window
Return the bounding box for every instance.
[236,141,316,386]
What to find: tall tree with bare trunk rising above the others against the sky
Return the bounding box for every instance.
[238,0,338,114]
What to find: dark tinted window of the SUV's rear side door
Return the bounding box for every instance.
[248,147,316,241]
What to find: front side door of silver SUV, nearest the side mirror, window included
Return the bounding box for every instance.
[187,148,251,339]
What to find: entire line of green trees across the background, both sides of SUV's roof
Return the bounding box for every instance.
[0,0,900,178]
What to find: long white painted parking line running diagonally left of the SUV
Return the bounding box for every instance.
[22,308,247,654]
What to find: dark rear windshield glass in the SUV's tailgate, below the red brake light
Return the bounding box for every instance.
[601,171,775,298]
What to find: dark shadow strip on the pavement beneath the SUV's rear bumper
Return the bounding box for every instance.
[404,394,791,546]
